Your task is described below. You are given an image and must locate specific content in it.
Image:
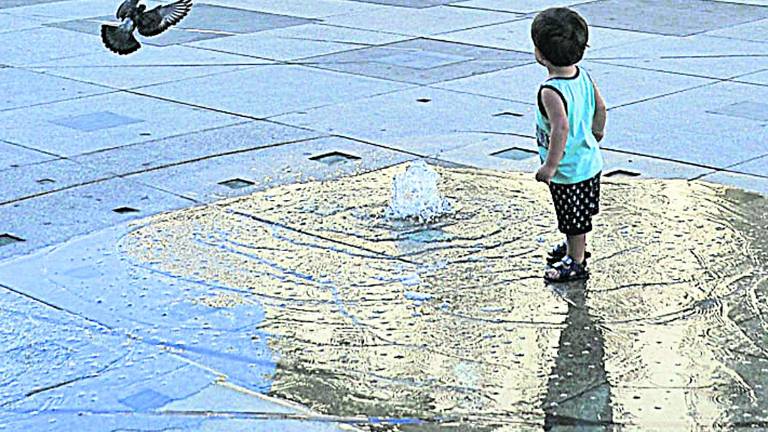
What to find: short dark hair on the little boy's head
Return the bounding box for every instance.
[531,8,589,66]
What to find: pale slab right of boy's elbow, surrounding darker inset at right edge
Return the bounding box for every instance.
[603,83,768,168]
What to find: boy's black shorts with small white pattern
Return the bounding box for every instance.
[549,173,600,235]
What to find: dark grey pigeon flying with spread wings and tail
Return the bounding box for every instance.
[101,0,192,55]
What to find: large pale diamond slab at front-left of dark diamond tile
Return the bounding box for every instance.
[141,65,414,118]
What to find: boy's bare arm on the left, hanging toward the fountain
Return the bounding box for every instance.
[536,88,569,183]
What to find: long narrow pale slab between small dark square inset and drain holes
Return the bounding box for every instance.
[73,121,319,175]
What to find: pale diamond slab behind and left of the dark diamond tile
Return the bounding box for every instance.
[191,24,407,61]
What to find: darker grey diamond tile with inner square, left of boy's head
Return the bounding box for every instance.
[305,39,533,84]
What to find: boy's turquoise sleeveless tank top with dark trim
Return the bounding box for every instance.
[536,67,603,184]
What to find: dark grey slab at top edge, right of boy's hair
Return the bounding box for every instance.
[573,0,768,36]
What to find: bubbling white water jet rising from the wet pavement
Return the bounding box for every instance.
[385,160,451,223]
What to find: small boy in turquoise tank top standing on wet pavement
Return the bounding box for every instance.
[531,8,606,282]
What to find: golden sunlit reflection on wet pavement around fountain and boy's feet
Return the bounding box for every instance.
[119,167,768,431]
